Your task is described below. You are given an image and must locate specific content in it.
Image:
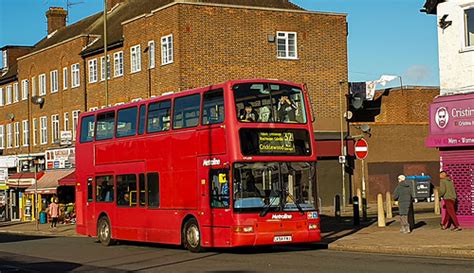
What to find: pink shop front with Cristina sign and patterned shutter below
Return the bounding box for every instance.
[426,93,474,228]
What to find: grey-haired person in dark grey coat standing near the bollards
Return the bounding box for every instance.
[393,175,413,233]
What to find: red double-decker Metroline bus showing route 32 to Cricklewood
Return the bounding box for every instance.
[76,80,320,252]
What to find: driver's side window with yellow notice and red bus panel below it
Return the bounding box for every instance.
[208,168,232,246]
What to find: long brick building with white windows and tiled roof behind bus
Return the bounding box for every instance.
[0,0,347,220]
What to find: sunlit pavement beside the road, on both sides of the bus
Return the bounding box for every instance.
[0,203,474,259]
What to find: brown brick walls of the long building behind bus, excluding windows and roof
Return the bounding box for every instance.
[0,3,347,154]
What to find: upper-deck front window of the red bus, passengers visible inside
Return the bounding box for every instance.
[232,83,306,123]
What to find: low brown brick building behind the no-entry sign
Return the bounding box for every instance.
[351,86,439,201]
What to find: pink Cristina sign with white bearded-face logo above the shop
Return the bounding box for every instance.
[426,94,474,147]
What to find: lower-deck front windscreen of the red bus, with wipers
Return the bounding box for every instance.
[233,162,317,216]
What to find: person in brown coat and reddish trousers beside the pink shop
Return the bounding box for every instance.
[439,171,462,231]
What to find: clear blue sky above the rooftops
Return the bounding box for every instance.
[0,0,439,86]
